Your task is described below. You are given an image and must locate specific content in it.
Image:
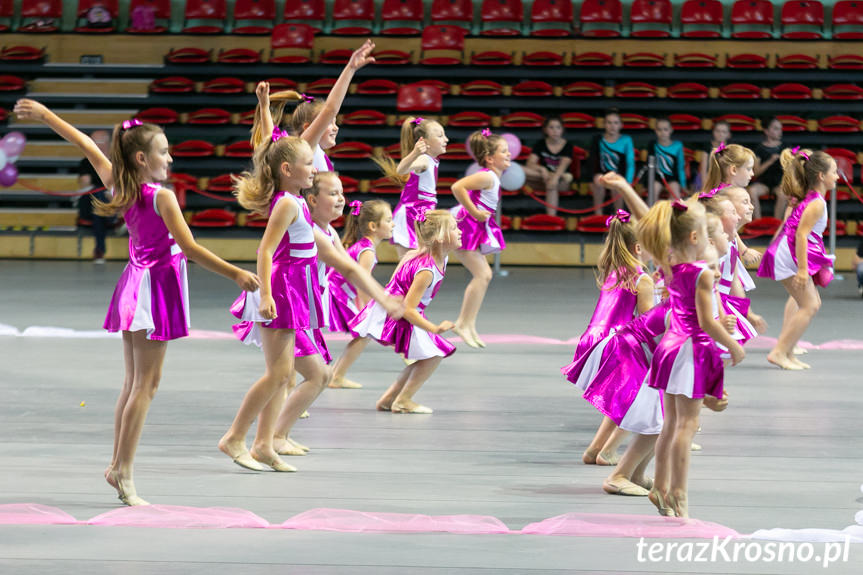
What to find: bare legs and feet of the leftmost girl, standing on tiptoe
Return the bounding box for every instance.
[108,330,168,506]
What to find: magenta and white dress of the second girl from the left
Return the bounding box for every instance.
[231,192,324,355]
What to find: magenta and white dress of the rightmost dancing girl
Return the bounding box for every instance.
[758,190,836,287]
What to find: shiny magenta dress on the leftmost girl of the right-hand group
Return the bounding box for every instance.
[561,270,645,391]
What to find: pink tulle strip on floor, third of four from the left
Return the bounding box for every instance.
[281,508,510,534]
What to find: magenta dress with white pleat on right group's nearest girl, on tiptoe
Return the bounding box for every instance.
[649,262,724,399]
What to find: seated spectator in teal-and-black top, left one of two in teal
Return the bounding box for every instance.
[590,108,635,214]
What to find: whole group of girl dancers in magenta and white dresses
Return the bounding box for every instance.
[15,41,836,517]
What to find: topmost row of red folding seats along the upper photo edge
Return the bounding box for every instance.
[5,0,863,40]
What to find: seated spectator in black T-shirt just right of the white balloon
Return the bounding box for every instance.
[524,116,572,216]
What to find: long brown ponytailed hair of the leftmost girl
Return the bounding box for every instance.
[93,123,165,216]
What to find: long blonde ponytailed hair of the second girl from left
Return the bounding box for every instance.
[234,136,311,216]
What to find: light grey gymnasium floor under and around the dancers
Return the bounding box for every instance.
[0,261,863,575]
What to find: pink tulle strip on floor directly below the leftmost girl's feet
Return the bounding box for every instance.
[86,505,270,529]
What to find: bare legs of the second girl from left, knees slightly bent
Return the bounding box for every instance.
[219,328,296,469]
